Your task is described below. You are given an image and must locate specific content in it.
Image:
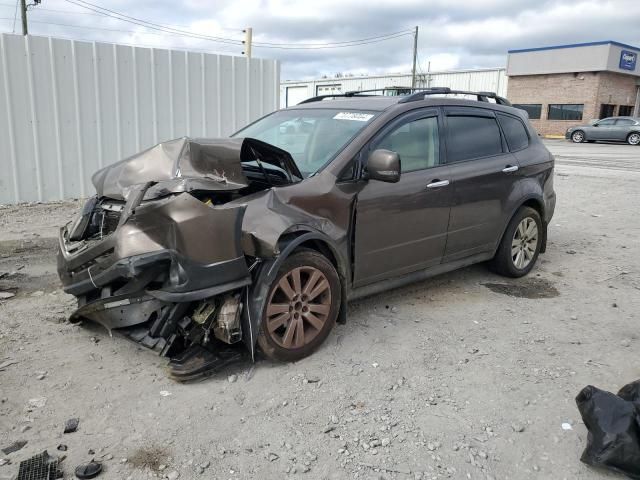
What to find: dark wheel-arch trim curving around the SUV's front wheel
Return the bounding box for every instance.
[241,231,348,361]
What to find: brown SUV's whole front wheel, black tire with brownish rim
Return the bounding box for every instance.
[258,249,342,362]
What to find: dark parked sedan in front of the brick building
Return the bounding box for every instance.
[565,117,640,145]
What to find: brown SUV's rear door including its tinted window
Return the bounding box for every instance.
[443,107,528,262]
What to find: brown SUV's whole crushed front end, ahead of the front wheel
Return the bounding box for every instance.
[58,139,302,379]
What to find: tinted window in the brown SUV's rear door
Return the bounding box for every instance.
[447,115,502,162]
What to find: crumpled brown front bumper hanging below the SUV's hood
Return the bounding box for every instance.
[58,193,250,334]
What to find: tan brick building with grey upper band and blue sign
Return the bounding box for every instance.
[507,41,640,135]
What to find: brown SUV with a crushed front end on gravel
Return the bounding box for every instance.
[58,88,555,378]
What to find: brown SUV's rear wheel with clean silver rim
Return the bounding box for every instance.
[490,207,543,278]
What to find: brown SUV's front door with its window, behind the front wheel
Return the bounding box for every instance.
[354,109,451,287]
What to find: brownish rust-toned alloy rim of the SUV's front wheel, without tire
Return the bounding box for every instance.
[265,267,331,349]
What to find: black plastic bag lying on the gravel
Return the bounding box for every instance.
[576,381,640,480]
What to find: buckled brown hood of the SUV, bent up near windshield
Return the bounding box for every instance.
[91,137,302,200]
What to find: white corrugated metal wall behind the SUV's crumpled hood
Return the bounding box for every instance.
[0,34,280,204]
